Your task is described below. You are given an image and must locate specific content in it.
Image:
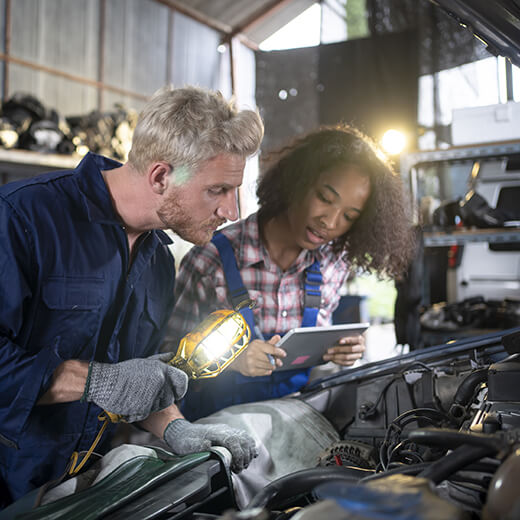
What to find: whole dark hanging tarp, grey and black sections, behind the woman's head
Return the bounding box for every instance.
[256,32,418,150]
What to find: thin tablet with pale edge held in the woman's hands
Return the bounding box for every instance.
[276,323,370,371]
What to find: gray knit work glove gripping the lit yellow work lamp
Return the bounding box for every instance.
[82,353,188,422]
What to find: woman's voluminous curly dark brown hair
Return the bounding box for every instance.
[256,124,415,278]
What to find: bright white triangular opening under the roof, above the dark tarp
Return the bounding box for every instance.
[260,4,321,51]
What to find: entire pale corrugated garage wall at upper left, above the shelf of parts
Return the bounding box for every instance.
[0,0,225,116]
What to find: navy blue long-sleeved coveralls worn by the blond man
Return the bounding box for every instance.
[0,154,175,506]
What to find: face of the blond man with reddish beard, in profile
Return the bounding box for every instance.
[157,154,245,245]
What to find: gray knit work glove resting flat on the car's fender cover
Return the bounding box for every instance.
[164,419,258,473]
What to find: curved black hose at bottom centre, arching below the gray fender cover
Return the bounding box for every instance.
[247,466,367,509]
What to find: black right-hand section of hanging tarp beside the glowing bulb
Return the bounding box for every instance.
[318,32,418,144]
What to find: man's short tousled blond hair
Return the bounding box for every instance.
[128,86,264,172]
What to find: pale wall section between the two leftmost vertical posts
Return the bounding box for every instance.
[8,0,99,114]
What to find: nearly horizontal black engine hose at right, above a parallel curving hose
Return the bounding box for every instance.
[407,428,504,452]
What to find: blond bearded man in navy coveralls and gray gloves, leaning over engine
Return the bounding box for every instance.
[0,87,263,506]
